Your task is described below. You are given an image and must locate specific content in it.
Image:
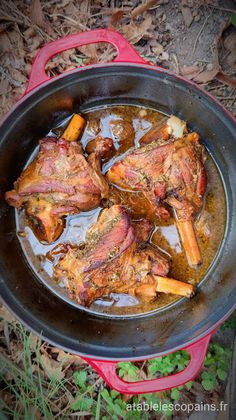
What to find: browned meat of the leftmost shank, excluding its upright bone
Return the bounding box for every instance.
[5,137,108,243]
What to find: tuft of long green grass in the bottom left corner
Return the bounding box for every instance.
[0,324,70,420]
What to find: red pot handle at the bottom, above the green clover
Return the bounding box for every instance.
[83,330,215,394]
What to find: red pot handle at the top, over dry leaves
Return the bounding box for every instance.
[26,29,147,93]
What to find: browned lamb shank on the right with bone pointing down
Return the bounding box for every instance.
[107,117,206,266]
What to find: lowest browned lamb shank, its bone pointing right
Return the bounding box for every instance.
[54,205,194,306]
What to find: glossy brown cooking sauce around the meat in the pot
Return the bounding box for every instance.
[17,105,226,315]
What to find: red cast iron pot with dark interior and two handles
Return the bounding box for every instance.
[0,29,236,394]
